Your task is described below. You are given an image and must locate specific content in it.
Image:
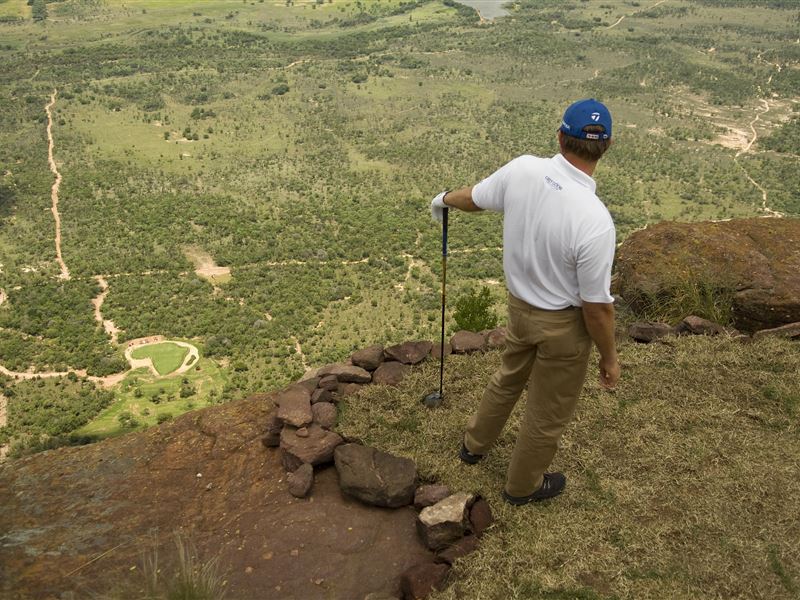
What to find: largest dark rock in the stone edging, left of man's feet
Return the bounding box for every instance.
[334,444,417,508]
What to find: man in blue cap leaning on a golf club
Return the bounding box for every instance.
[431,99,620,505]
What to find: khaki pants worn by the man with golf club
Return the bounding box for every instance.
[464,294,591,496]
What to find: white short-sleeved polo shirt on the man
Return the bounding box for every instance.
[472,154,616,310]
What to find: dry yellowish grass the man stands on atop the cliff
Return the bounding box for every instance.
[340,337,800,600]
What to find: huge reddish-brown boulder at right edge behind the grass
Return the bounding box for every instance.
[615,218,800,333]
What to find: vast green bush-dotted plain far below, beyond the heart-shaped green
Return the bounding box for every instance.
[0,0,800,450]
